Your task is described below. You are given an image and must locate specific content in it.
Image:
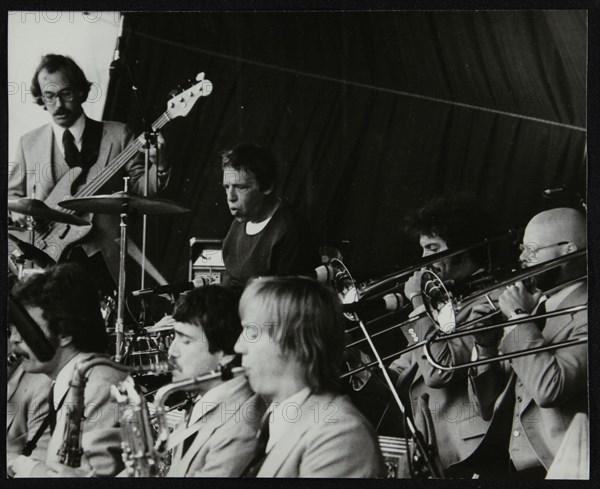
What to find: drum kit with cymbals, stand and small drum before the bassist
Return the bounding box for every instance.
[7,185,189,365]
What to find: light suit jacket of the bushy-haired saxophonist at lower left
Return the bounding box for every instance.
[27,355,127,477]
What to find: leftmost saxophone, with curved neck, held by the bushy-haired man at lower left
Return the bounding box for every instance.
[58,355,163,467]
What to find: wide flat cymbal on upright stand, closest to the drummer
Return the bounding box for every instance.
[58,192,189,215]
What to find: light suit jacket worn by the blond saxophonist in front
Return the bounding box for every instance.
[257,394,385,477]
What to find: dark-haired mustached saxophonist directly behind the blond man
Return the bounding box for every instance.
[162,285,266,477]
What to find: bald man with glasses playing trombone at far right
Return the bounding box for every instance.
[469,208,588,479]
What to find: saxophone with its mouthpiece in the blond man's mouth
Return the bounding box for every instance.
[112,365,244,477]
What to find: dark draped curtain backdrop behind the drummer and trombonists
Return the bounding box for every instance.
[105,11,587,281]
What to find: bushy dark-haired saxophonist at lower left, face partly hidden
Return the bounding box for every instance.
[9,263,127,477]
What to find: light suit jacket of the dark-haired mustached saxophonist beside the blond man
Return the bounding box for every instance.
[167,377,266,477]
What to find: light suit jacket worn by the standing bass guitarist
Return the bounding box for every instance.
[8,117,167,264]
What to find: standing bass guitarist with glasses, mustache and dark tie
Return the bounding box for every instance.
[8,54,169,290]
